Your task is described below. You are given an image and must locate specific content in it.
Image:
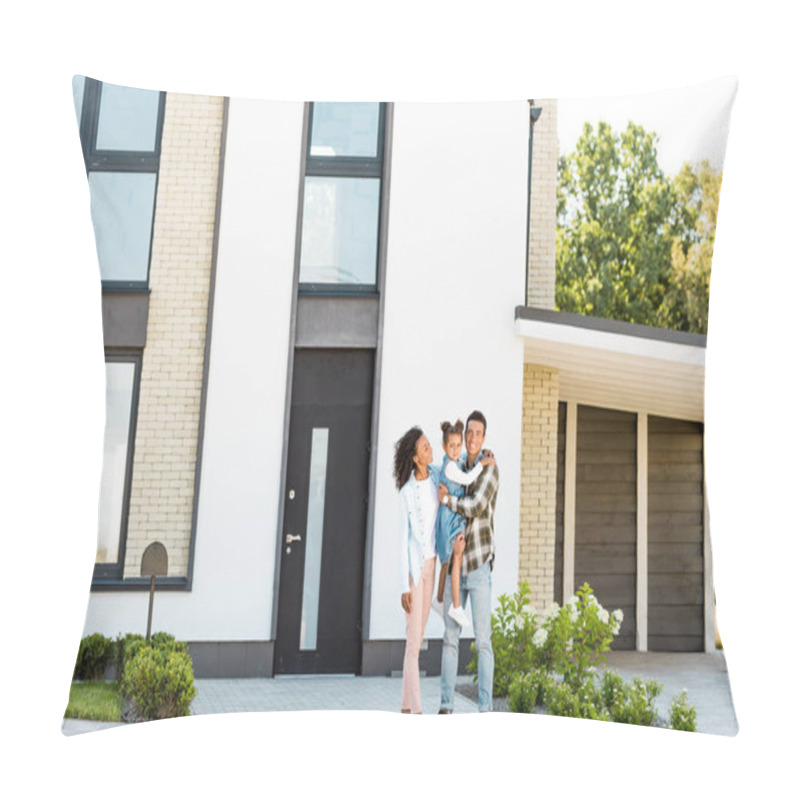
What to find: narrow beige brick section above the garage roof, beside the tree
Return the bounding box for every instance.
[528,100,558,309]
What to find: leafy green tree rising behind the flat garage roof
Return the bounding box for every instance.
[556,122,721,332]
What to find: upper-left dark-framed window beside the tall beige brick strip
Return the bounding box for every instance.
[73,76,164,289]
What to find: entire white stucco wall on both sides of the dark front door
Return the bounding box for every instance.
[85,99,528,641]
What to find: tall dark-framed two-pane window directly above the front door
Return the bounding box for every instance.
[300,103,384,292]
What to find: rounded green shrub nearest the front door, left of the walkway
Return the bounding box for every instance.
[120,637,197,720]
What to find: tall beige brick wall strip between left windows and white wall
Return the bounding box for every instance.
[124,94,223,578]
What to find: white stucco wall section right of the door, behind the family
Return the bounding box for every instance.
[369,101,528,639]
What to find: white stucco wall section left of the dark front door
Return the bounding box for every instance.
[85,99,303,641]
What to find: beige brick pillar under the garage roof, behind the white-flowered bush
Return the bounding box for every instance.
[519,364,558,612]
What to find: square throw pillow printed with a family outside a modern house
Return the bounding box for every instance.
[65,76,737,735]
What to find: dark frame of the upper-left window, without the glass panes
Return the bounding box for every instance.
[78,77,167,292]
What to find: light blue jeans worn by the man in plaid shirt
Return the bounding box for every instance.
[440,562,494,711]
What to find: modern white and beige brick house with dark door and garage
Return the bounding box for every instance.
[75,78,714,677]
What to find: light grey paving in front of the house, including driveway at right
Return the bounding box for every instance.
[62,652,738,736]
